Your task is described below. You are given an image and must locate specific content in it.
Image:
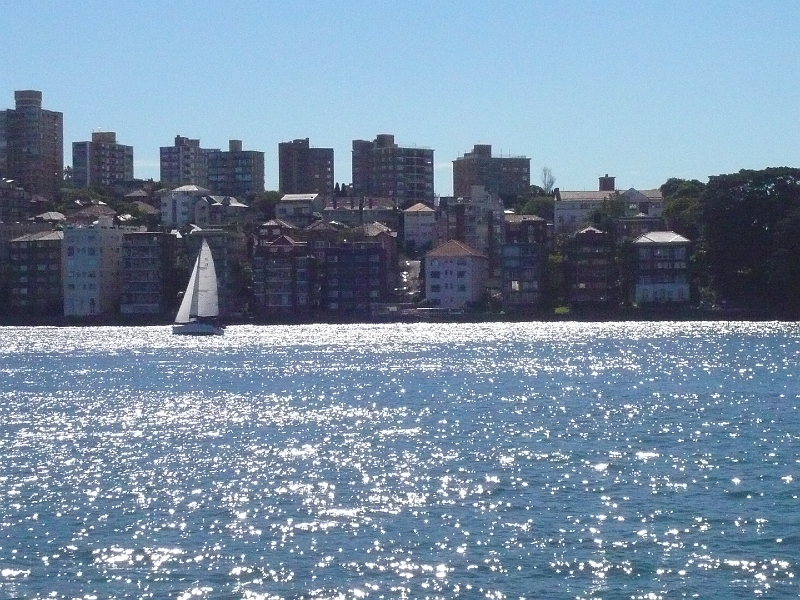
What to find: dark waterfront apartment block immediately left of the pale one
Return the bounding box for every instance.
[9,231,64,315]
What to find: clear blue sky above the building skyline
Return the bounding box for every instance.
[6,0,800,195]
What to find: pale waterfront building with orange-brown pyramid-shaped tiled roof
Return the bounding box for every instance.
[424,240,487,310]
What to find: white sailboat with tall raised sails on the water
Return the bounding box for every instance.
[172,239,224,335]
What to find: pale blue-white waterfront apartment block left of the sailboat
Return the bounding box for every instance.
[62,217,139,317]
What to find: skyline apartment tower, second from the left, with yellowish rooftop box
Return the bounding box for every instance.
[72,131,133,189]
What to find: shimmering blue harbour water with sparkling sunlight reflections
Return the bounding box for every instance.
[0,323,800,599]
